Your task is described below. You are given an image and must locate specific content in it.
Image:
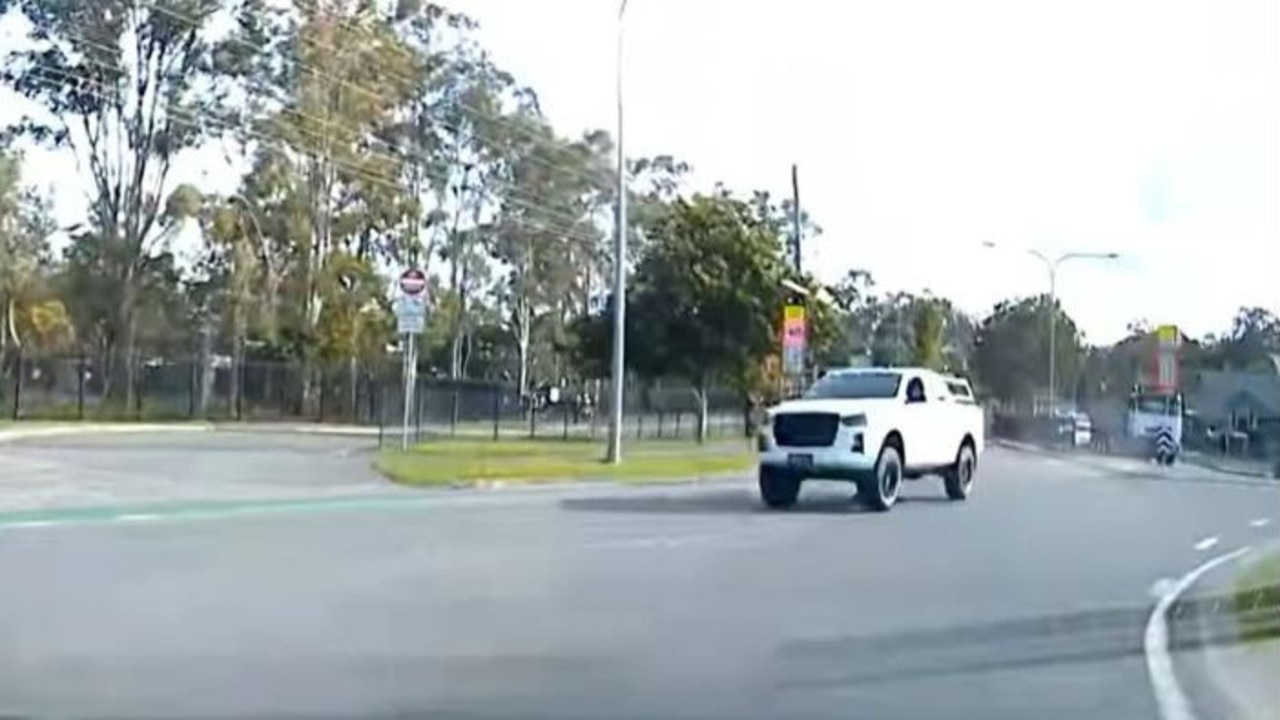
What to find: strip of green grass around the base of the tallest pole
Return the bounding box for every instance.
[374,438,755,486]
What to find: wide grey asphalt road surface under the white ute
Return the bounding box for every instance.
[0,436,1277,720]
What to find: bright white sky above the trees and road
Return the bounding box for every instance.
[0,0,1280,342]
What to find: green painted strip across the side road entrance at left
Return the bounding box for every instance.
[0,495,439,529]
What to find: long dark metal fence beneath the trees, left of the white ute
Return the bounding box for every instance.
[0,354,750,439]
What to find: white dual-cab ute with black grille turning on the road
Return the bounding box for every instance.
[758,368,984,511]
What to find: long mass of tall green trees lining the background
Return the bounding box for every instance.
[0,0,1280,420]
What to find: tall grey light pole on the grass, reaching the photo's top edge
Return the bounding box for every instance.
[608,0,627,465]
